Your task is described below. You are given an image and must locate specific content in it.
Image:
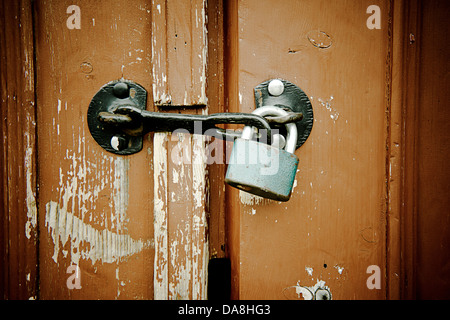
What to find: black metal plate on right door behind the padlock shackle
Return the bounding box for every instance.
[254,79,314,148]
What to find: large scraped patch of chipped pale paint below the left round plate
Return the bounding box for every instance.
[45,126,153,265]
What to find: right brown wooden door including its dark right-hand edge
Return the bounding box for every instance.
[226,0,448,299]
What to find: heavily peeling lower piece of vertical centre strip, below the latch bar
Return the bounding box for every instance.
[153,133,209,300]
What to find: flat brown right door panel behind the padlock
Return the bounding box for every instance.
[227,0,390,299]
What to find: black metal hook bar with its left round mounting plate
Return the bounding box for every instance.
[88,80,303,155]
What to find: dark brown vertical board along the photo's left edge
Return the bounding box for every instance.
[0,1,38,299]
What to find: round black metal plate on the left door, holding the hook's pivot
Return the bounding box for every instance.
[87,80,147,155]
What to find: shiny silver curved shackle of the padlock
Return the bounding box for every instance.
[241,106,298,153]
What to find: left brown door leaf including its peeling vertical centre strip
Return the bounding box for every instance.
[35,0,214,299]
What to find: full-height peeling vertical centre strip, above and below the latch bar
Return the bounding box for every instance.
[151,0,210,300]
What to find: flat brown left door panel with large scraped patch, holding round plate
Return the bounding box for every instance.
[36,1,154,299]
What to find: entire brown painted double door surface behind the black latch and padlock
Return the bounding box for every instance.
[0,0,450,299]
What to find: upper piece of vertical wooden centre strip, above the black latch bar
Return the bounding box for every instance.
[152,0,208,106]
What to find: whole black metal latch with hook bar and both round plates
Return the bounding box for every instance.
[88,79,313,155]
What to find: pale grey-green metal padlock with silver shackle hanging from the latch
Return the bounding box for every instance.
[225,106,298,201]
